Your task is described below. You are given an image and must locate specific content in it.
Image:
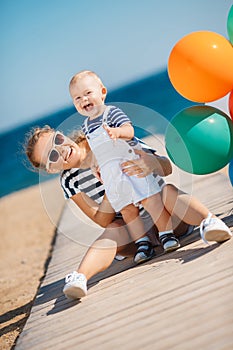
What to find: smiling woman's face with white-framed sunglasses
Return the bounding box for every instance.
[34,132,87,173]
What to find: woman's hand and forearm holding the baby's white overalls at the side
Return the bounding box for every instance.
[121,150,172,178]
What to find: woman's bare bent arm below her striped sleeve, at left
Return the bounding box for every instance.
[71,192,115,227]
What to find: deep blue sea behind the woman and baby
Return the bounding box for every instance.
[0,69,194,197]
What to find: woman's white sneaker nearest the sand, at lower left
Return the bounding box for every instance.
[63,271,87,299]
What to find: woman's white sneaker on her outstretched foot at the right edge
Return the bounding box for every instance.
[200,213,232,244]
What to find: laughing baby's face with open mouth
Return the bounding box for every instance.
[70,75,107,117]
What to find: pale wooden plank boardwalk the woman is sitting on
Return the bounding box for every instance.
[16,172,233,350]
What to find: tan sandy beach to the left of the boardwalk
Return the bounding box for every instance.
[0,179,64,350]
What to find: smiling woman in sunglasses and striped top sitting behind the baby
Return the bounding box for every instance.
[25,126,232,299]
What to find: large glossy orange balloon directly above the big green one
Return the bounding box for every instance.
[168,31,233,103]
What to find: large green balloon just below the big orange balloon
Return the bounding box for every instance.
[165,106,233,175]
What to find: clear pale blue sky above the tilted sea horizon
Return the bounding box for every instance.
[0,0,232,132]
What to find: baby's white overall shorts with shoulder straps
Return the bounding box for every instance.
[84,106,161,212]
